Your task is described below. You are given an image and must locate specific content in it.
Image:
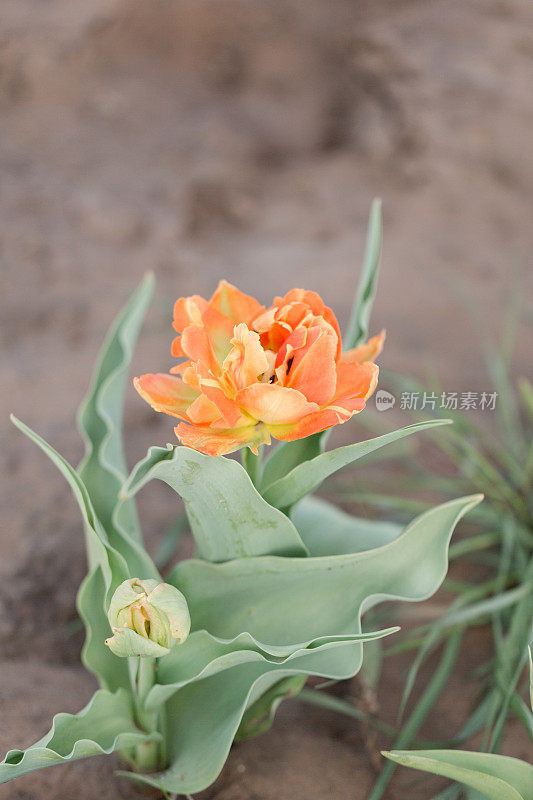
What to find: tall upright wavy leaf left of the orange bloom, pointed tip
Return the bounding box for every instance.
[78,275,159,578]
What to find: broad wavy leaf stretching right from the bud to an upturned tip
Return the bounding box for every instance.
[168,495,481,645]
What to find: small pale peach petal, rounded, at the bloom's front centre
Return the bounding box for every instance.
[235,383,318,425]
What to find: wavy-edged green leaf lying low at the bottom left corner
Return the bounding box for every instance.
[0,690,159,783]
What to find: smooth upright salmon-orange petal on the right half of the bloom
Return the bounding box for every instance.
[285,328,337,406]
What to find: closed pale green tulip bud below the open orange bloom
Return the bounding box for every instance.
[105,578,191,658]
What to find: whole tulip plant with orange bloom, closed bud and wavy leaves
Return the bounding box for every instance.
[0,203,481,794]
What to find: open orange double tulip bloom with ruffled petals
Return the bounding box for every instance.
[134,281,384,455]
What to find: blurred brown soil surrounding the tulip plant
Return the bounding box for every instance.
[0,0,533,800]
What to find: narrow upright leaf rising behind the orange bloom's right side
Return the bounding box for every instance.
[344,199,382,350]
